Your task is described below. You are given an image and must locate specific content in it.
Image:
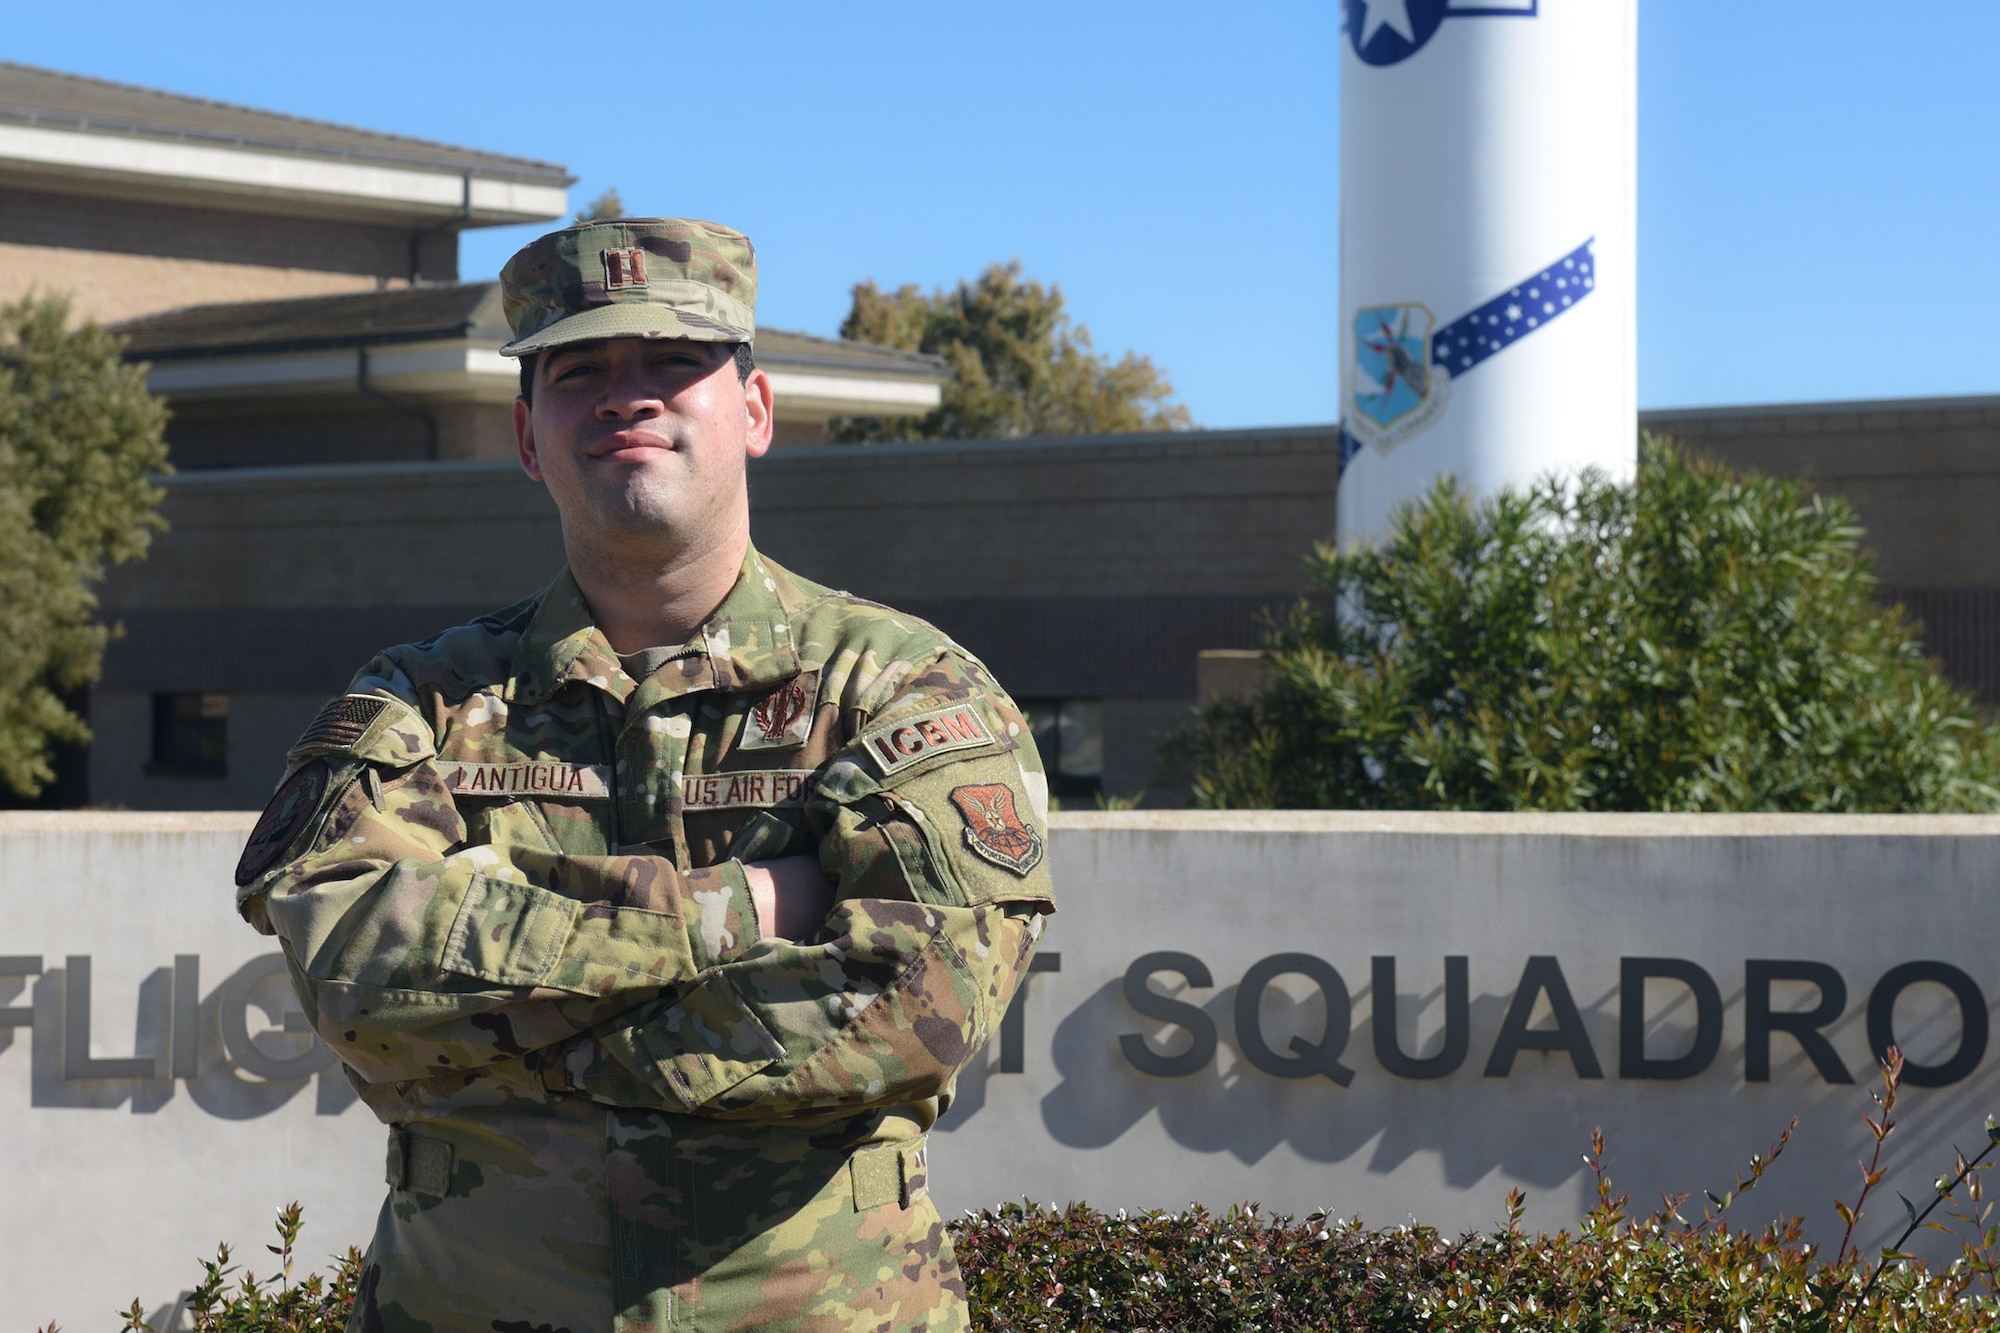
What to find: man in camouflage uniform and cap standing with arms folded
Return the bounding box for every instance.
[238,218,1052,1333]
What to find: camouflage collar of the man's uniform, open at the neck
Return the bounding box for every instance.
[508,546,798,707]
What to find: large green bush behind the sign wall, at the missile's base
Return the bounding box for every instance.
[1170,440,2000,811]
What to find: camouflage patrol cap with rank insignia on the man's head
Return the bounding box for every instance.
[500,218,756,356]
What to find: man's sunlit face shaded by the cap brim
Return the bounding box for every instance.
[514,338,772,548]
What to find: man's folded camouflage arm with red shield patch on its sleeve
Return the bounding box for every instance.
[564,668,1054,1117]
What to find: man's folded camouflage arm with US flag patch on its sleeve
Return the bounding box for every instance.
[238,701,758,1083]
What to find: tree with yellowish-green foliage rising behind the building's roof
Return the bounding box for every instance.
[830,260,1194,442]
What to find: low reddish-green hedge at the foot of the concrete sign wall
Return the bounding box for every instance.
[90,1049,2000,1333]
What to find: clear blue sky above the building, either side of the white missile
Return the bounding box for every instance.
[0,0,2000,426]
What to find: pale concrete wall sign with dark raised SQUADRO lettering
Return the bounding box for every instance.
[0,813,2000,1327]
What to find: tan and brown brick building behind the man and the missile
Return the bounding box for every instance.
[0,64,2000,809]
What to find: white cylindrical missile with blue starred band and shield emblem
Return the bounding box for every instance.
[1338,0,1638,540]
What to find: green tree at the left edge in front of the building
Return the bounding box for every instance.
[0,296,166,797]
